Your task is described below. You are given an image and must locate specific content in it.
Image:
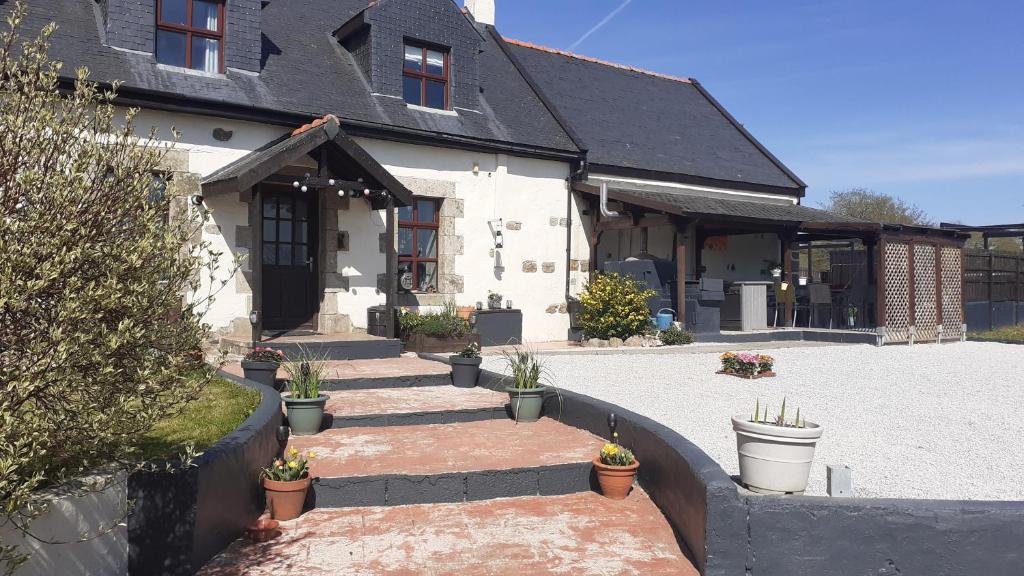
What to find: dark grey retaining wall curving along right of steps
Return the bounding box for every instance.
[462,357,1024,576]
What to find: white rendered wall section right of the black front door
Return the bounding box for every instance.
[348,138,588,341]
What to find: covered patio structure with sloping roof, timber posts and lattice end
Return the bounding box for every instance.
[572,180,969,343]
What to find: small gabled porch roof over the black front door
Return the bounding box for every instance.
[203,115,413,208]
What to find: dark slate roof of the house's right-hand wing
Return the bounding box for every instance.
[506,40,805,196]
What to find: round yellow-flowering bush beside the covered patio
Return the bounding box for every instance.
[578,274,654,339]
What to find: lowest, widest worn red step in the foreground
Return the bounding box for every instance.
[200,489,698,576]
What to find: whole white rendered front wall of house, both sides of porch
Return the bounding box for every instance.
[122,111,589,341]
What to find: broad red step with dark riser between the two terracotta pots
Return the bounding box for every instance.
[289,418,603,507]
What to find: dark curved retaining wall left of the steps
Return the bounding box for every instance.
[128,372,282,576]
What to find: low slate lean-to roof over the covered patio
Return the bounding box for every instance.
[585,180,868,224]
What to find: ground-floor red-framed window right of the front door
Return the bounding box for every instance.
[398,198,441,292]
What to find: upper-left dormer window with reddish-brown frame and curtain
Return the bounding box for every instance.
[157,0,224,74]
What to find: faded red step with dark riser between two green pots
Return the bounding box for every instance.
[325,385,508,428]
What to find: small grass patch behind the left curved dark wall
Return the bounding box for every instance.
[138,377,261,460]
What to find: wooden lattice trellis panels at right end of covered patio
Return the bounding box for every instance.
[880,240,964,343]
